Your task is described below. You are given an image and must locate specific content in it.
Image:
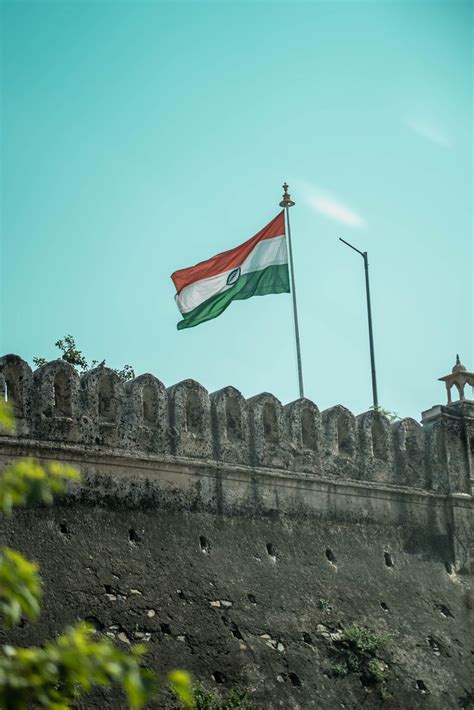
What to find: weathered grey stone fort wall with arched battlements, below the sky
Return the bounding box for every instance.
[0,356,474,709]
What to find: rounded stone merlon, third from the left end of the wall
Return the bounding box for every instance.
[81,366,124,447]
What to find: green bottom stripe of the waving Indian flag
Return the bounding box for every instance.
[178,264,290,330]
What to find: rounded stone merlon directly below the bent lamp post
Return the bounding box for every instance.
[356,411,397,483]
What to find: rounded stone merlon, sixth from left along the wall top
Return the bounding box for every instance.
[210,387,250,465]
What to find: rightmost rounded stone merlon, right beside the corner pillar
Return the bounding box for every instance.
[392,418,428,488]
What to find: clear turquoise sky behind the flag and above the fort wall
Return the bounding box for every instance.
[0,0,474,418]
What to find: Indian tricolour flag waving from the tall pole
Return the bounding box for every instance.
[171,210,290,330]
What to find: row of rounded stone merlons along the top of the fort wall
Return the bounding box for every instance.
[0,354,474,493]
